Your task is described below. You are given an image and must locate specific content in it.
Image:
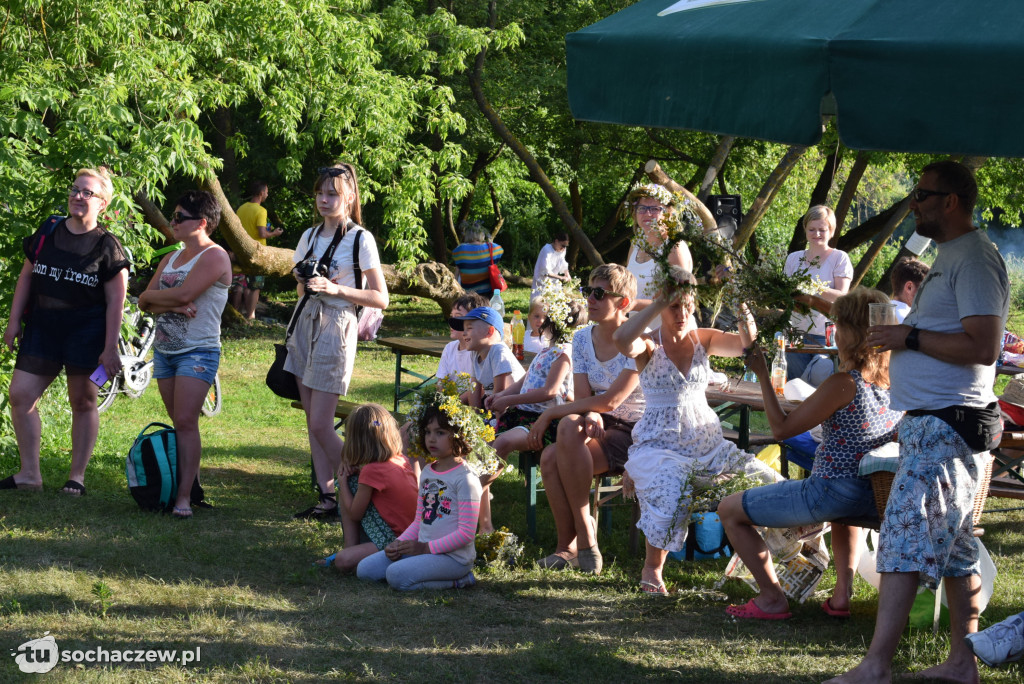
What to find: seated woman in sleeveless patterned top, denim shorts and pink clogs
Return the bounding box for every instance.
[718,288,903,619]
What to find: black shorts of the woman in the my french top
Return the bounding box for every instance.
[14,306,106,377]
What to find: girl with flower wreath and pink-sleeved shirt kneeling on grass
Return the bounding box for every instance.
[356,381,494,591]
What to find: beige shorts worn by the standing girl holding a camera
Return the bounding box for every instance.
[285,299,358,394]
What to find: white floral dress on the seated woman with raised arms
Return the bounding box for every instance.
[626,331,775,551]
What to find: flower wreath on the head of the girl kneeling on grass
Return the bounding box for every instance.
[409,373,502,474]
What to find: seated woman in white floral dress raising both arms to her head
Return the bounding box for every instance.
[614,267,776,594]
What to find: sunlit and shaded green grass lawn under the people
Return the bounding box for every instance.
[0,286,1024,683]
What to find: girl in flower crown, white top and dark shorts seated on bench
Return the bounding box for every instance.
[480,281,587,535]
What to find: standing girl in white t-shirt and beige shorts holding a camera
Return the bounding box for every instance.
[285,164,388,519]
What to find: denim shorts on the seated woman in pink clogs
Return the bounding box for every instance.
[743,475,879,527]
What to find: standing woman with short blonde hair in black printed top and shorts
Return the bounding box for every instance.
[0,168,128,496]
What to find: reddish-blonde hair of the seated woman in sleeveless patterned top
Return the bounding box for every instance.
[830,288,889,387]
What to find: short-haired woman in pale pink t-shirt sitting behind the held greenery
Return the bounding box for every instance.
[783,205,853,387]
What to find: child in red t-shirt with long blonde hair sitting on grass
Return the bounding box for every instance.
[316,403,416,572]
